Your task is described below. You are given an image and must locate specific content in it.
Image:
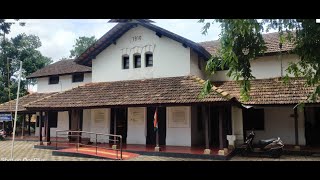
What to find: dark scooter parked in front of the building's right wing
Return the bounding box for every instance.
[240,131,284,158]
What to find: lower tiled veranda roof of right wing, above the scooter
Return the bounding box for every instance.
[213,78,320,104]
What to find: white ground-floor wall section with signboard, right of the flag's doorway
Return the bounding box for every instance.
[166,106,191,146]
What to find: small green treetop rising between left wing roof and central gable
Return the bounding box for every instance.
[69,36,97,58]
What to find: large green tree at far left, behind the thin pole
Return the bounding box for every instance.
[0,33,52,103]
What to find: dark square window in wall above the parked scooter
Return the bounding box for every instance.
[243,108,264,130]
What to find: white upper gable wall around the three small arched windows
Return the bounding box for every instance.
[92,26,190,82]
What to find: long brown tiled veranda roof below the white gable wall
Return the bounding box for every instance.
[26,76,234,109]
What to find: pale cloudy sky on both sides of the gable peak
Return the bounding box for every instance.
[8,19,220,62]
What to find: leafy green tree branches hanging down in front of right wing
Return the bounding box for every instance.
[199,19,320,101]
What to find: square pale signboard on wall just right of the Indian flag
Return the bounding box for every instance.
[168,107,189,128]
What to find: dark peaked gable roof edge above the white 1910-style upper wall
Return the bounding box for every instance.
[75,19,211,65]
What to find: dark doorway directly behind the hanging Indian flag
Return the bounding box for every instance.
[146,107,167,145]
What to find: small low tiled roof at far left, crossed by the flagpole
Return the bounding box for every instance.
[0,93,55,113]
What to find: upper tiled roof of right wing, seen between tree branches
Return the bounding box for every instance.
[200,32,294,55]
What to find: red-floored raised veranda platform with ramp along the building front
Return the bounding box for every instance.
[34,143,234,160]
